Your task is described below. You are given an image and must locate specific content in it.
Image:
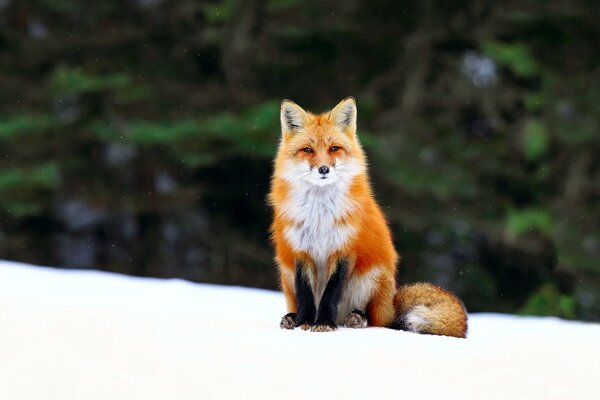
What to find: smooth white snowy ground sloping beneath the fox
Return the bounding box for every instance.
[0,261,600,400]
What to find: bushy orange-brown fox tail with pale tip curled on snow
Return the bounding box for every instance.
[391,283,467,338]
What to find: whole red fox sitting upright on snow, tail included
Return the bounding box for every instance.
[269,97,467,338]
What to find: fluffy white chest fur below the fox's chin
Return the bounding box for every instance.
[283,184,356,271]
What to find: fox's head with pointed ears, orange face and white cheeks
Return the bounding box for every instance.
[276,97,366,186]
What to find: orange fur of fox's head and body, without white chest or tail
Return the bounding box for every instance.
[269,98,466,334]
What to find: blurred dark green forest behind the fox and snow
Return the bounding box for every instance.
[0,0,600,320]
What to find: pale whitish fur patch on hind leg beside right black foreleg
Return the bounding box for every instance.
[337,268,381,325]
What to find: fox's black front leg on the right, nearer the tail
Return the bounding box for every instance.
[312,259,348,332]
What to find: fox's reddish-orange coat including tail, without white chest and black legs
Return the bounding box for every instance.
[269,98,467,337]
